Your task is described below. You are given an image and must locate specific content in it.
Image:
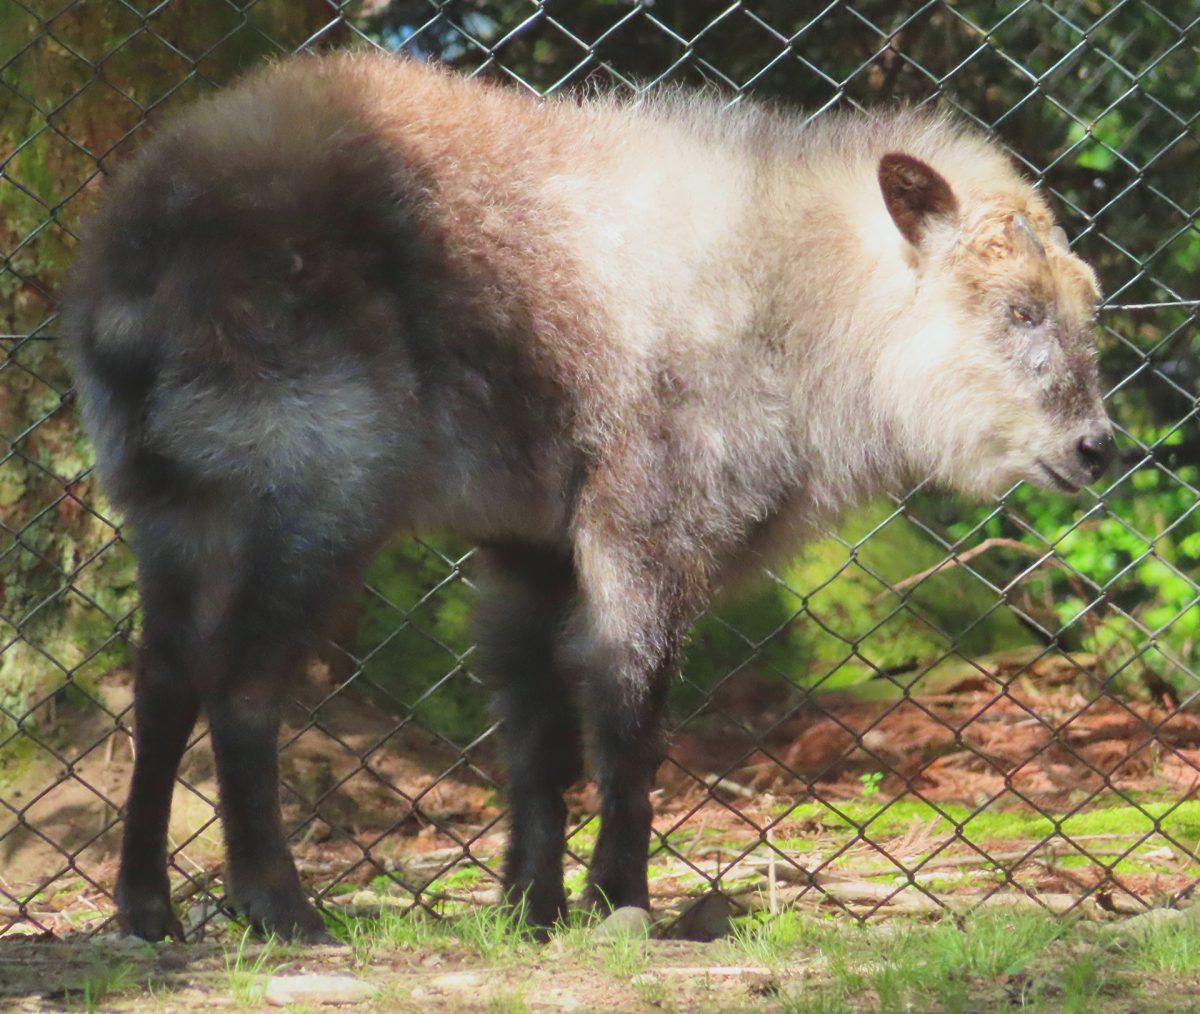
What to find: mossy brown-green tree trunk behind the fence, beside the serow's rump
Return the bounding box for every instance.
[0,0,367,729]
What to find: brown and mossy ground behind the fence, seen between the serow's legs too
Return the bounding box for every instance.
[0,653,1200,940]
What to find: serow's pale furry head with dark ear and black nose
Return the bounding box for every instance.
[878,152,1115,494]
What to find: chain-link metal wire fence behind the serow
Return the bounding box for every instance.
[0,0,1200,934]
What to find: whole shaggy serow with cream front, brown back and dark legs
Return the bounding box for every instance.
[67,55,1111,940]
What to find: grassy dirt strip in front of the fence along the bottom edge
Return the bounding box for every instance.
[7,912,1200,1014]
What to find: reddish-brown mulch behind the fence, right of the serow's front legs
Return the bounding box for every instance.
[667,656,1200,810]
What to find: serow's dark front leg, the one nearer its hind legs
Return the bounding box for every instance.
[479,547,582,928]
